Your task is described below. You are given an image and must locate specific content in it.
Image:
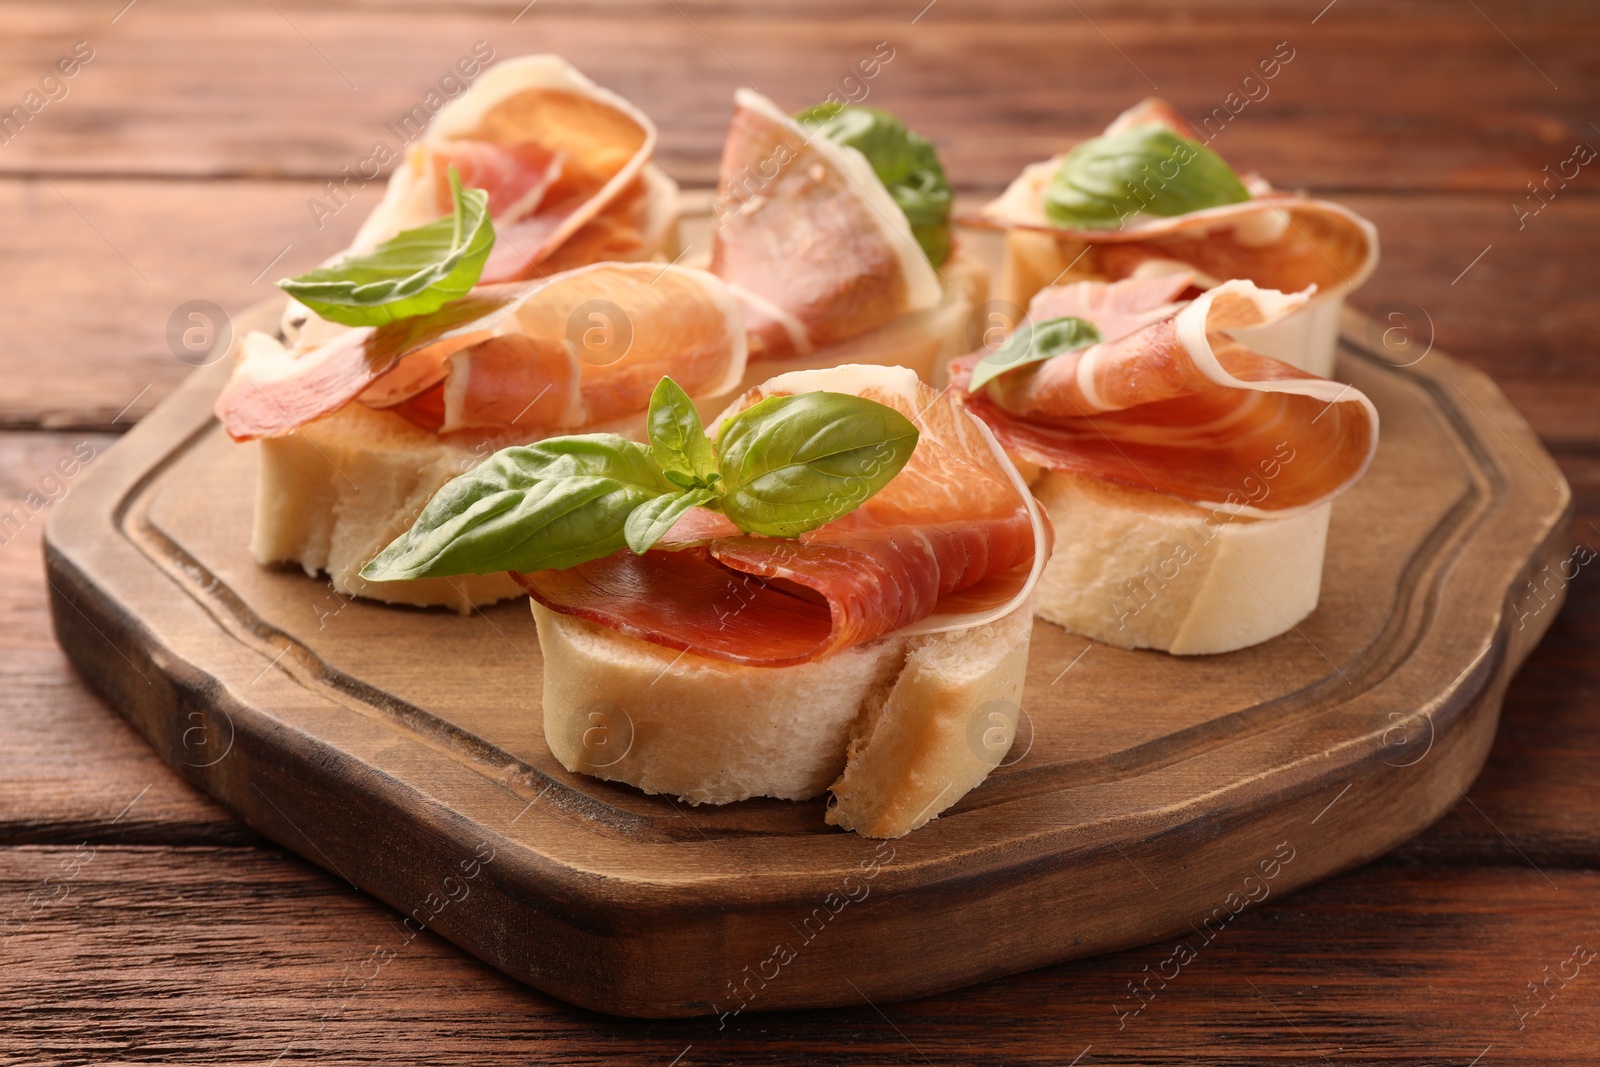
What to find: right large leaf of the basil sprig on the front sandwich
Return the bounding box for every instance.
[717,392,918,537]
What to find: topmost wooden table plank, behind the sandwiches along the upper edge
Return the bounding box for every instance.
[0,0,1600,192]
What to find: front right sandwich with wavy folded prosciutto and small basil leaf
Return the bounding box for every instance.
[950,274,1378,653]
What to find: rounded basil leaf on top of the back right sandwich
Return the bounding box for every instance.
[1045,125,1250,229]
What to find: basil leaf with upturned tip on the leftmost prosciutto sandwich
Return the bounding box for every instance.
[278,166,494,326]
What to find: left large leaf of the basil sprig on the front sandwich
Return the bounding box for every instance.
[362,434,674,581]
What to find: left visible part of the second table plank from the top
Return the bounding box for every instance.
[0,179,378,430]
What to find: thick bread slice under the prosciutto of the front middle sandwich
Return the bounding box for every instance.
[533,601,1032,837]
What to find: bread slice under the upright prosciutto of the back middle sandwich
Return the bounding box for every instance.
[699,248,989,419]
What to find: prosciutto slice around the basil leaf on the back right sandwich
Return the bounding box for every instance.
[962,98,1378,300]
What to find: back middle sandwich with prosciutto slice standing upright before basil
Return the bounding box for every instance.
[710,90,989,399]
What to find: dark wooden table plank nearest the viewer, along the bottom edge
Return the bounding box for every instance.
[0,840,1600,1067]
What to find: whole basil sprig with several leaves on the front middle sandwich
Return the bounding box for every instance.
[362,378,918,581]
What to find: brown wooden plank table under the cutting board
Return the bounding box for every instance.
[0,0,1600,1067]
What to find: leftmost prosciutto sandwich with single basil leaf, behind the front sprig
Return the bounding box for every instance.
[216,178,746,609]
